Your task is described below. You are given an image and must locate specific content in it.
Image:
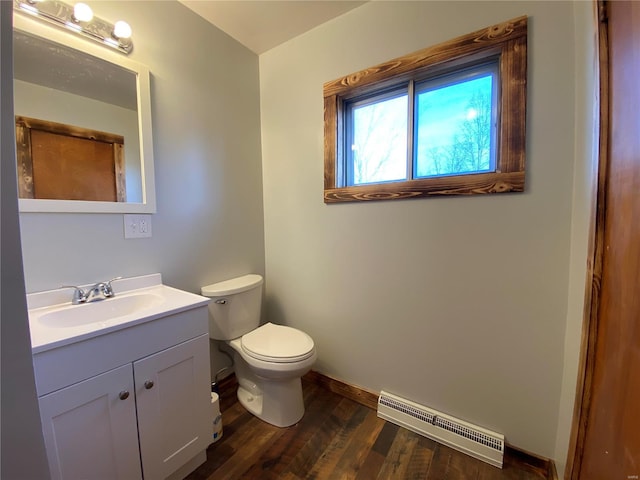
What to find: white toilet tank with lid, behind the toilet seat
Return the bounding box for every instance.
[201,274,263,340]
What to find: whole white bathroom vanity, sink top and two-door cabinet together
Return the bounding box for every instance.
[27,274,212,480]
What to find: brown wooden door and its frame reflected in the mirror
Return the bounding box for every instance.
[16,116,127,202]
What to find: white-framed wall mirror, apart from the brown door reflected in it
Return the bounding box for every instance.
[13,13,155,213]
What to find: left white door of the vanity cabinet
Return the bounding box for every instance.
[38,364,142,480]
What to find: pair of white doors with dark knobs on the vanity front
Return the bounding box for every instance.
[39,335,211,480]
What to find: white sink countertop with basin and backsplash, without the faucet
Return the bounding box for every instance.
[27,274,209,354]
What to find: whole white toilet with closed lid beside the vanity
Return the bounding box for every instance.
[201,274,317,427]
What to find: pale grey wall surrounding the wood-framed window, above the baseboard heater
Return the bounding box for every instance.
[260,1,576,457]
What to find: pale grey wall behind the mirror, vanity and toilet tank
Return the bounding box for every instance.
[20,1,264,373]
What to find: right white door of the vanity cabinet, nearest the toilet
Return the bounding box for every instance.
[133,334,212,480]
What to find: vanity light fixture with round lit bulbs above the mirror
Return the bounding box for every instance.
[13,0,133,54]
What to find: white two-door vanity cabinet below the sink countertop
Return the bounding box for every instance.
[33,286,212,480]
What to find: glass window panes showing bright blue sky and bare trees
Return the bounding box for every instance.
[348,71,495,185]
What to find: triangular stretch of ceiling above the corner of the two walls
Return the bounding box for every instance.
[180,0,365,55]
